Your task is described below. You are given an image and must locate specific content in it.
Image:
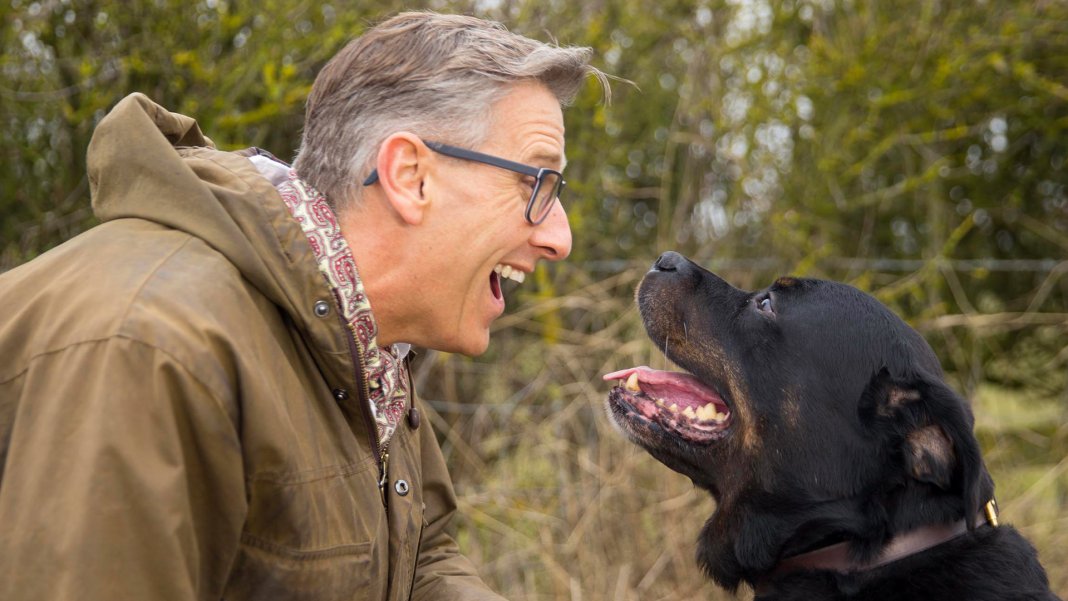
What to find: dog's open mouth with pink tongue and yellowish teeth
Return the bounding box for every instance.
[604,366,731,443]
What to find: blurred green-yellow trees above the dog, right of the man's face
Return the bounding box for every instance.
[494,0,1068,399]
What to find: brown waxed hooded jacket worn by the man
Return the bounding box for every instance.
[0,94,501,601]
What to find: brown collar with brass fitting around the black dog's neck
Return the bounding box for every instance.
[755,499,998,595]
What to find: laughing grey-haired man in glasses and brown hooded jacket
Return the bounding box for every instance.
[0,13,607,600]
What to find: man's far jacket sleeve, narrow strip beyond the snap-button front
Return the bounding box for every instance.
[412,403,504,601]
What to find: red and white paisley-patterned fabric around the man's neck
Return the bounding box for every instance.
[278,170,408,448]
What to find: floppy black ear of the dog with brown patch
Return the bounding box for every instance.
[860,369,983,523]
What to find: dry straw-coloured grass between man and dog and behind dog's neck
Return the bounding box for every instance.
[417,268,1068,601]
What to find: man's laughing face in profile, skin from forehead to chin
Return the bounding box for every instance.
[412,83,571,355]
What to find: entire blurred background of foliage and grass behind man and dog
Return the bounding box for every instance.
[0,0,1068,601]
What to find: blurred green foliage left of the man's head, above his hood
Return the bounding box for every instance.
[0,0,407,269]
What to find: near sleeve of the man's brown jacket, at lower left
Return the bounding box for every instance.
[0,337,246,601]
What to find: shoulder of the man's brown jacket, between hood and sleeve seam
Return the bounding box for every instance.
[0,219,277,392]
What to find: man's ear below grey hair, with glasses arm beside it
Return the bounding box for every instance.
[376,131,431,225]
